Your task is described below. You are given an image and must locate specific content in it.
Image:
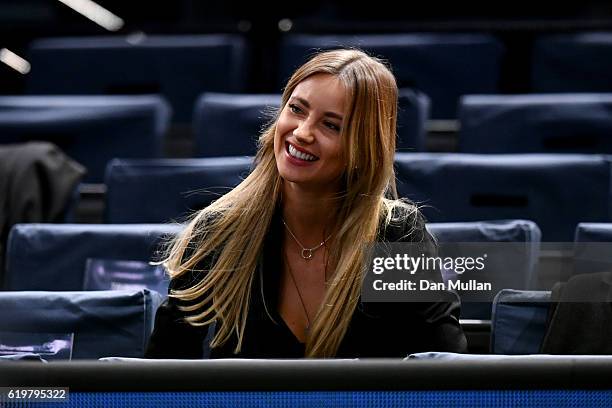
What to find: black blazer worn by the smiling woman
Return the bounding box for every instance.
[145,207,467,359]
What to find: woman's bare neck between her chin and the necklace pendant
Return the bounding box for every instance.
[282,182,338,247]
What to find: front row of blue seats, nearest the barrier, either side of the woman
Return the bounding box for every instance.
[0,289,550,362]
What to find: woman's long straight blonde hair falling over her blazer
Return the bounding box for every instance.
[165,49,416,357]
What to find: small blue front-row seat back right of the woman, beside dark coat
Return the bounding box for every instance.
[491,289,550,354]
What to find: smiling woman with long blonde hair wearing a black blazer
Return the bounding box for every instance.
[147,50,466,358]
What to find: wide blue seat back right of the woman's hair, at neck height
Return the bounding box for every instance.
[395,153,610,242]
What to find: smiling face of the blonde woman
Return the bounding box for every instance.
[274,74,346,190]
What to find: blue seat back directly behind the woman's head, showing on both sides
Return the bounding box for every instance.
[193,89,429,157]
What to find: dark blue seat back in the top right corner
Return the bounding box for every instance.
[532,32,612,92]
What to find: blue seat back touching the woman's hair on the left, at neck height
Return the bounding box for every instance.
[105,157,253,224]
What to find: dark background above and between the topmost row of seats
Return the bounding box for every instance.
[0,0,612,94]
